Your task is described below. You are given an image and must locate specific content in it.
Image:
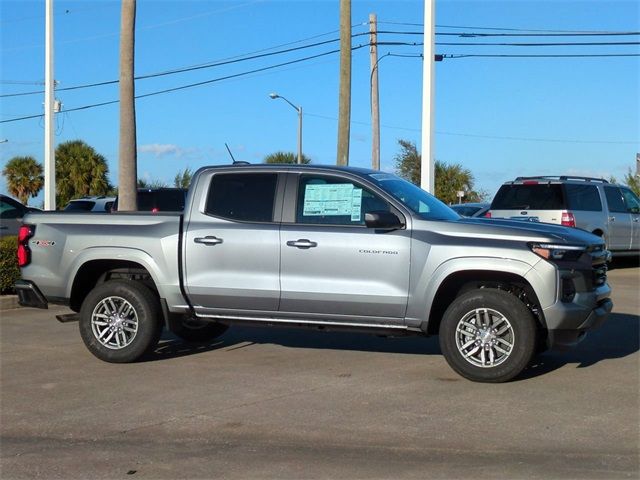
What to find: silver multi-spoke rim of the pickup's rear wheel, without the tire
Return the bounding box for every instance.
[91,297,138,350]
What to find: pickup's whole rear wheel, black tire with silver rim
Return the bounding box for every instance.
[80,280,162,363]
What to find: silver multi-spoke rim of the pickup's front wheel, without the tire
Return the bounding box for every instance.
[456,308,515,368]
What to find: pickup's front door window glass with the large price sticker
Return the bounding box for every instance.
[296,175,390,225]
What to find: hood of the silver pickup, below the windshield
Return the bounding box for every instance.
[414,218,604,246]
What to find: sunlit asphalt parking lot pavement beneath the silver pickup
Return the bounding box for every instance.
[0,262,640,479]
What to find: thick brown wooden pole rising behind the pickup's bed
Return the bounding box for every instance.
[118,0,138,212]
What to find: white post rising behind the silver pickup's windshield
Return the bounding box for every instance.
[420,0,436,193]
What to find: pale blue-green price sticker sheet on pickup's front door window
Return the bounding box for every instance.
[302,183,362,222]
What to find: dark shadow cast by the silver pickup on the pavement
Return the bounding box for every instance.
[146,313,640,381]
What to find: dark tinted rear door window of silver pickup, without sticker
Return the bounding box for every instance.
[205,173,278,222]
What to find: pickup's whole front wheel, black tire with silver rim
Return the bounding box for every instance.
[440,288,536,383]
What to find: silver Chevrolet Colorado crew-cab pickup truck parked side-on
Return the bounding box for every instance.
[16,165,613,382]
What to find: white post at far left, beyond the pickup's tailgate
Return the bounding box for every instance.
[44,0,56,210]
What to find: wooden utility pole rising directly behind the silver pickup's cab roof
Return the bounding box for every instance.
[337,0,351,165]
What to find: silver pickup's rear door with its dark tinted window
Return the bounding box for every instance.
[183,170,284,316]
